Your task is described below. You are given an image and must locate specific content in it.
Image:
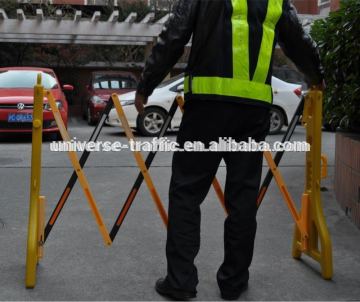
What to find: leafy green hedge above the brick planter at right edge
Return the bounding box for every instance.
[311,0,360,132]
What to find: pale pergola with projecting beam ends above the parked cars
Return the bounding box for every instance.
[0,9,323,45]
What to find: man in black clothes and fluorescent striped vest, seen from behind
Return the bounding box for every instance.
[135,0,323,299]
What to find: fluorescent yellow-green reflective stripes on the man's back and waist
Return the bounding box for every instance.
[184,0,283,103]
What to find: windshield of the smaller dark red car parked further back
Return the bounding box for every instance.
[93,75,137,89]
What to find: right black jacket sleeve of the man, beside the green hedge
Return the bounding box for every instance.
[278,0,324,85]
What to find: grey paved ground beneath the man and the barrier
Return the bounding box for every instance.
[0,121,360,301]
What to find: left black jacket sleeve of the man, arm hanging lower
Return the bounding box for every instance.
[137,0,200,97]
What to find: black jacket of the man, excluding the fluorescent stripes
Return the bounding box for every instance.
[137,0,323,104]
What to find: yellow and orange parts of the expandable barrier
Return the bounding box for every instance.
[25,81,333,288]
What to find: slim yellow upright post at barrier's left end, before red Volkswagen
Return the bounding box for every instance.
[25,74,44,288]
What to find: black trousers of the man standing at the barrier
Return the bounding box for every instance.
[166,101,270,294]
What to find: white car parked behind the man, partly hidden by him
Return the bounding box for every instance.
[106,75,302,136]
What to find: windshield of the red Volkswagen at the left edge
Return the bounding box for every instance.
[0,70,58,89]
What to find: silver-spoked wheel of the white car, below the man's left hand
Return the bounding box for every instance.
[137,107,166,136]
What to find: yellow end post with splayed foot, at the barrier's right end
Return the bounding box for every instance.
[292,90,333,279]
